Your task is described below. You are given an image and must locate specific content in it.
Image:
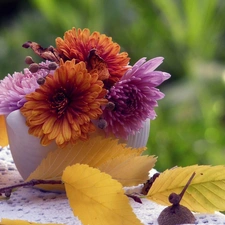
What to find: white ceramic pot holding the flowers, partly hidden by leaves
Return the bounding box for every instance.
[6,110,150,180]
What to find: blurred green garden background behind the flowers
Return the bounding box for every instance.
[0,0,225,171]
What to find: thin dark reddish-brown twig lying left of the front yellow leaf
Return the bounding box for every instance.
[0,179,62,197]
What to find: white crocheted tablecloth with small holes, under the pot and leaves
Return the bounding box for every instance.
[0,147,225,225]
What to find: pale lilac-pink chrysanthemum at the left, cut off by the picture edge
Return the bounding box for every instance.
[0,61,54,115]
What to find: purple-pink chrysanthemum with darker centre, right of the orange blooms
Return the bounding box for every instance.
[103,57,170,140]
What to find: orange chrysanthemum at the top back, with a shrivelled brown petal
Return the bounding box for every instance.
[56,28,130,83]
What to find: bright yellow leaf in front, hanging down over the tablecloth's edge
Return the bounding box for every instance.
[62,164,142,225]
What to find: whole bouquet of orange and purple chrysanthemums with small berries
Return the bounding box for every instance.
[0,28,170,181]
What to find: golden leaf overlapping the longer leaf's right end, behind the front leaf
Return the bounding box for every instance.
[99,155,156,187]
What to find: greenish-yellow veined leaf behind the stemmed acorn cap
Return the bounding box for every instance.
[147,165,225,213]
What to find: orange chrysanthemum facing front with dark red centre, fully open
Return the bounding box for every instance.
[21,60,107,147]
